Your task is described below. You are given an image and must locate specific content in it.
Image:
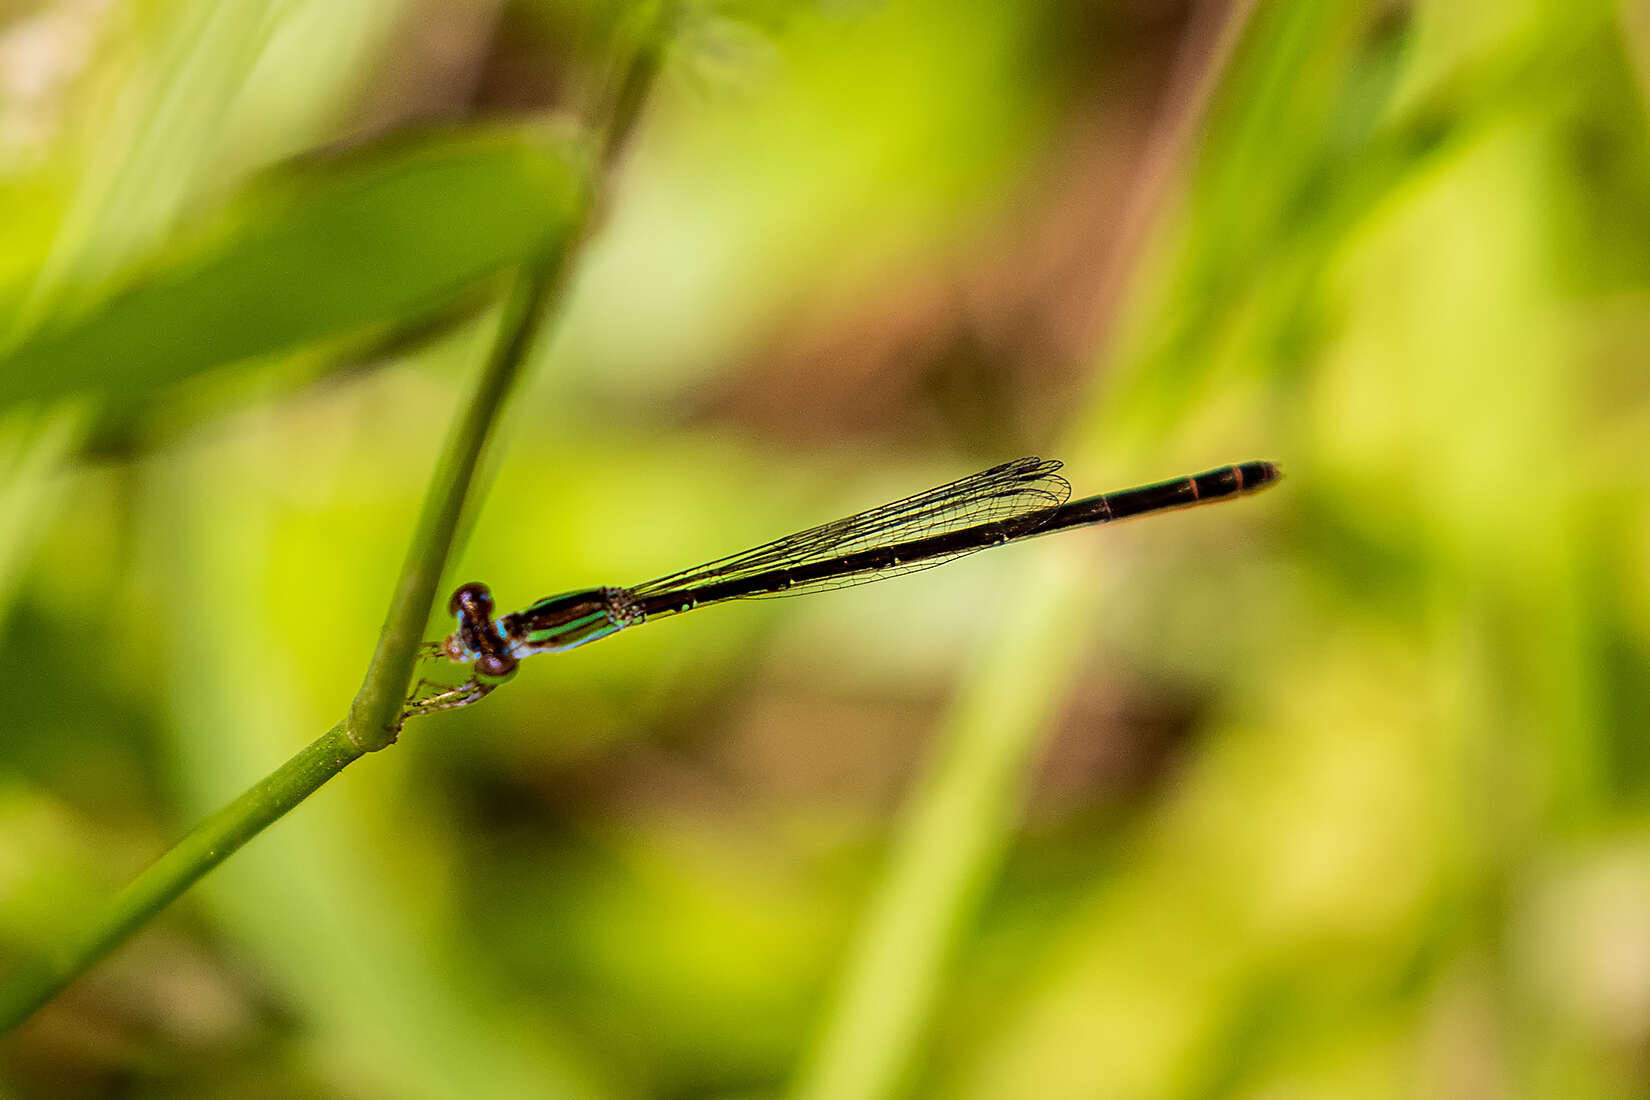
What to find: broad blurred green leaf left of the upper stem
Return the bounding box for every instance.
[0,127,587,404]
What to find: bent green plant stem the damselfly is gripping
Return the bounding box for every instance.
[0,8,663,1034]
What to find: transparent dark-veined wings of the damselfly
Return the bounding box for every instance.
[630,457,1071,599]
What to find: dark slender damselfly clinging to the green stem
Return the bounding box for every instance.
[404,458,1282,717]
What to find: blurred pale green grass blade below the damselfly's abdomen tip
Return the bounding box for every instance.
[790,556,1087,1100]
